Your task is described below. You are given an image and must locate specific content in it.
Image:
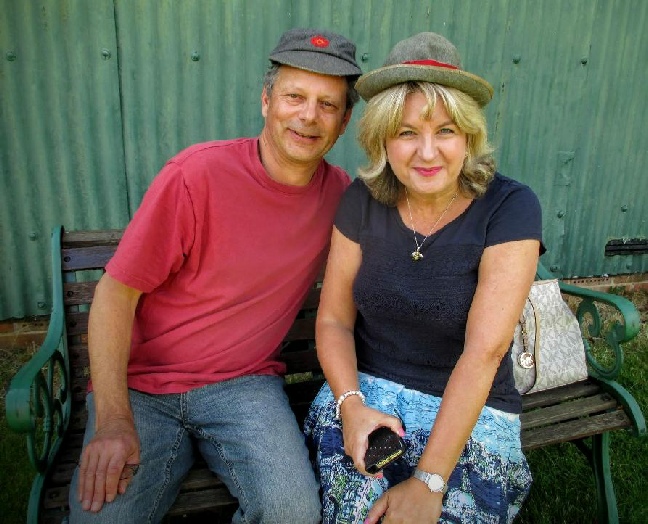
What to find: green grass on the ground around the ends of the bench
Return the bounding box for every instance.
[0,290,648,524]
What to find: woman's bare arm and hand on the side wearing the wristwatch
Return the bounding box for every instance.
[367,240,539,523]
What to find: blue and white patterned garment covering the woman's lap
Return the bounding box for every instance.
[304,373,531,524]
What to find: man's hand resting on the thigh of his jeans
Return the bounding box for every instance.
[77,418,140,513]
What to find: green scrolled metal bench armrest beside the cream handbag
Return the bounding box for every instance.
[537,264,641,380]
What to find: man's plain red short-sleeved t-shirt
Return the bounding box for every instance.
[106,139,350,393]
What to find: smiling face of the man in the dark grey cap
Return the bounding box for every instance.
[261,66,351,174]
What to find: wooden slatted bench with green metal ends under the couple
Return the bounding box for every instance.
[6,227,646,523]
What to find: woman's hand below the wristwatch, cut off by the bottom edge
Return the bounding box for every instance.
[364,478,443,524]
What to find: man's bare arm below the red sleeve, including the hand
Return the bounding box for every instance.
[77,273,142,512]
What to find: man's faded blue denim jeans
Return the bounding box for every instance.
[69,376,321,524]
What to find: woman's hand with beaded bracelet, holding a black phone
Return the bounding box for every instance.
[340,397,405,476]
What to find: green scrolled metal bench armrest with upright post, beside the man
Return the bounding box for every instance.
[5,227,71,473]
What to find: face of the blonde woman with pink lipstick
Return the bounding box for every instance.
[386,92,468,199]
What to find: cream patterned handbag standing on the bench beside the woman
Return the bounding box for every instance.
[511,280,587,395]
